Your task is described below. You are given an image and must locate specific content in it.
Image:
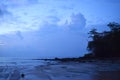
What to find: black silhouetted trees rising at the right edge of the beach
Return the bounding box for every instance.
[87,22,120,57]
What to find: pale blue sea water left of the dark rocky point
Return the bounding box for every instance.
[0,57,44,66]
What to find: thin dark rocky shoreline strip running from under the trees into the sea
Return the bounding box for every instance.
[32,57,120,62]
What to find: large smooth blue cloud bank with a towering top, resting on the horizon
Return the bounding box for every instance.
[1,13,87,57]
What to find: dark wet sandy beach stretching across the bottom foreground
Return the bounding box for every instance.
[0,60,120,80]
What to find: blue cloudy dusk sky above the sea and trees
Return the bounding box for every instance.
[0,0,120,58]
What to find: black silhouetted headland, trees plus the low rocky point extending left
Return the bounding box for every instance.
[52,22,120,62]
